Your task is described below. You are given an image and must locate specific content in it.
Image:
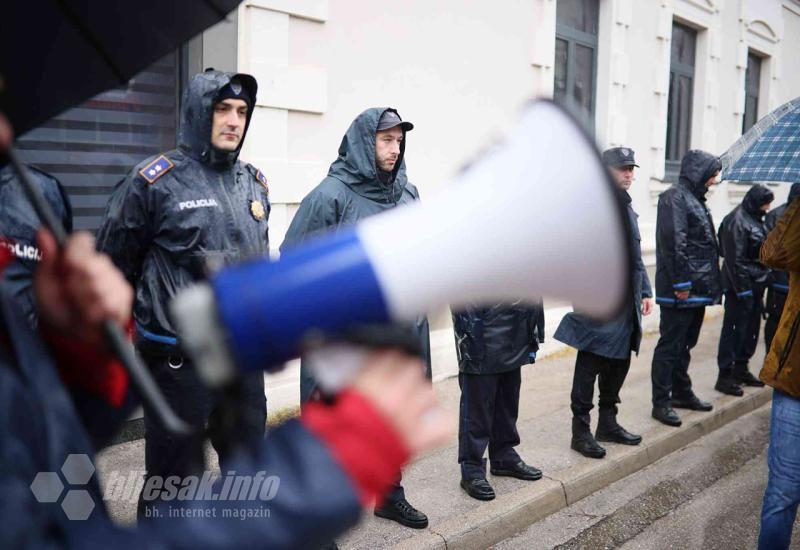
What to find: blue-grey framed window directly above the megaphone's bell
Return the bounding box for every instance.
[553,0,599,130]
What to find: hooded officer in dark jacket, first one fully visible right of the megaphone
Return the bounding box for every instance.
[651,149,722,426]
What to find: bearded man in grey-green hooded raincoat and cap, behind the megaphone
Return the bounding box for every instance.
[281,107,431,529]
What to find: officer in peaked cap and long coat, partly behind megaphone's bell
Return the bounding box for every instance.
[555,147,653,458]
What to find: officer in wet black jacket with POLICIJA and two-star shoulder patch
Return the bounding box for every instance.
[97,70,270,516]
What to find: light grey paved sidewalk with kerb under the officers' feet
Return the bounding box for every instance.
[98,308,768,550]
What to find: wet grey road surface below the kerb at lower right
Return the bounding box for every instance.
[493,405,800,550]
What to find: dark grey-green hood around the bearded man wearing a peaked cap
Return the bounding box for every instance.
[328,107,408,202]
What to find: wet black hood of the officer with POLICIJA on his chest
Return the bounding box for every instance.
[178,70,258,164]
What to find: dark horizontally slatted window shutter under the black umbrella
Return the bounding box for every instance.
[17,53,180,231]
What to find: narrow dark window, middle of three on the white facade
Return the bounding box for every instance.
[665,23,697,181]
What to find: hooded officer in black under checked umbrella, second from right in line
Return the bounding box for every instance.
[714,185,775,396]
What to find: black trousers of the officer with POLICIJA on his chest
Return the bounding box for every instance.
[137,356,267,518]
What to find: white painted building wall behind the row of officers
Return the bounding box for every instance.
[230,0,800,412]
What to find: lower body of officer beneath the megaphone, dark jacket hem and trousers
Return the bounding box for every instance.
[453,302,544,500]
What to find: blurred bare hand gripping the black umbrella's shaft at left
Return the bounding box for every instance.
[33,229,133,344]
